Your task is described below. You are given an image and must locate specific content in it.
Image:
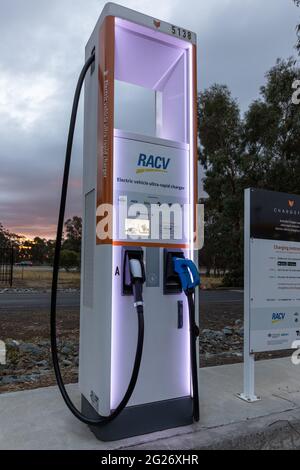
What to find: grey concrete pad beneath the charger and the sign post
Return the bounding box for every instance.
[0,358,300,450]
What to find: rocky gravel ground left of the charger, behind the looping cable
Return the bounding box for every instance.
[0,309,79,393]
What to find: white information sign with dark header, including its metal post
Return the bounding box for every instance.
[239,189,300,402]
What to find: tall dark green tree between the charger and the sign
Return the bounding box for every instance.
[198,85,244,285]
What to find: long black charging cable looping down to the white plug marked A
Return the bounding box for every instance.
[50,54,144,426]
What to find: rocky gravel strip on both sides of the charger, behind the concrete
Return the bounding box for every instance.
[0,303,290,393]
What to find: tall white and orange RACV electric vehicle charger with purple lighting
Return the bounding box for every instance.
[52,3,199,440]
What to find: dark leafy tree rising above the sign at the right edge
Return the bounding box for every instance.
[243,58,300,194]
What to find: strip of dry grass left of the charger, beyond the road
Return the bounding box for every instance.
[13,267,80,289]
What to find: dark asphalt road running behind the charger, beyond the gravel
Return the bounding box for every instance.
[0,290,243,311]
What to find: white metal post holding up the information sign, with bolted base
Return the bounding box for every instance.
[238,189,260,403]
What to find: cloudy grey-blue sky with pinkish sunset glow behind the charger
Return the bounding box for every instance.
[0,0,299,237]
